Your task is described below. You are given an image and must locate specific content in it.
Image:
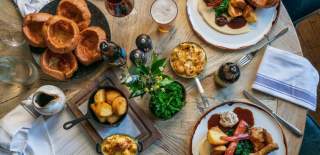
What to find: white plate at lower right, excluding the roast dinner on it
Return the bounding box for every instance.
[190,102,288,155]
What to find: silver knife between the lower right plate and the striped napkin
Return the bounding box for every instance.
[243,90,303,137]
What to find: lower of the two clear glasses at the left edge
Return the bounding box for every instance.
[0,56,39,85]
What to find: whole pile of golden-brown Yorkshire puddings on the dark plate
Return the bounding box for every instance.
[22,0,106,80]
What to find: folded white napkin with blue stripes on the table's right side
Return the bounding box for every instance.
[252,46,319,111]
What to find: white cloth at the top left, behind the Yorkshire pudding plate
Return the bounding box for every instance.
[13,0,50,17]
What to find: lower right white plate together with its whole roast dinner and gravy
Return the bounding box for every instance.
[190,101,287,155]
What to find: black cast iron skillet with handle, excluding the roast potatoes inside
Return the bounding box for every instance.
[63,86,129,130]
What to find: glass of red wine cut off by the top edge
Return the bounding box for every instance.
[105,0,134,17]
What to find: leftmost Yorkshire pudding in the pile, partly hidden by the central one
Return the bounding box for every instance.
[22,13,52,47]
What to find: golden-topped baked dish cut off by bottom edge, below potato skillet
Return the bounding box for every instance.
[101,134,138,155]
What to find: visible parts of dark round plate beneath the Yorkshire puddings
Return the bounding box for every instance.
[29,0,111,80]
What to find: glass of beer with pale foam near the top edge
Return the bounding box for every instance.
[150,0,178,32]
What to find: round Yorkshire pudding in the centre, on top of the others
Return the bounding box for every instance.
[42,16,80,54]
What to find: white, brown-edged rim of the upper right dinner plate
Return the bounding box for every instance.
[186,0,281,51]
